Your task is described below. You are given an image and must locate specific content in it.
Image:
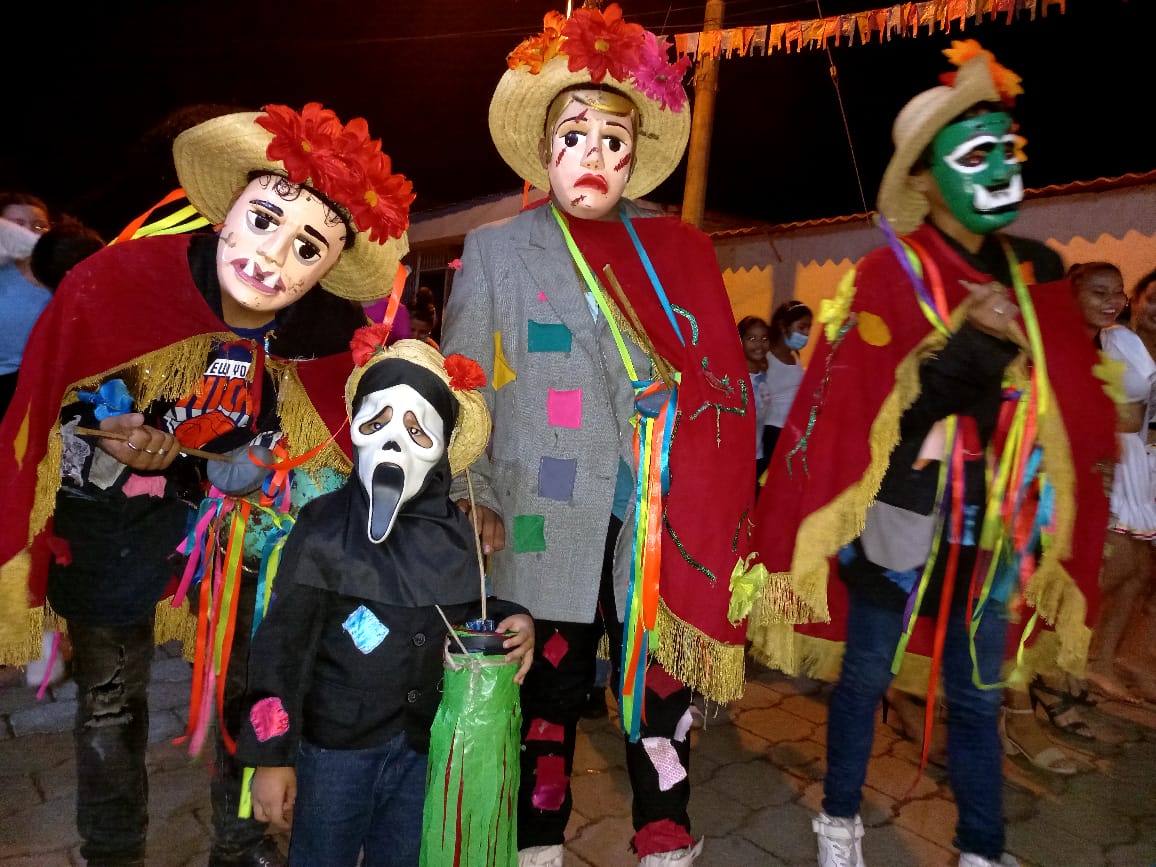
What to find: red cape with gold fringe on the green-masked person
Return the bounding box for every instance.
[751,224,1116,687]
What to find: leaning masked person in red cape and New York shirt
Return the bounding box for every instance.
[0,103,413,867]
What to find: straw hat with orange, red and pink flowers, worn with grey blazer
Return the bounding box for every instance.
[489,3,690,199]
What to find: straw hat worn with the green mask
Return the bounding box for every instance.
[876,39,1023,235]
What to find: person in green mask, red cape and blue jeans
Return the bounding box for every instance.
[750,40,1116,866]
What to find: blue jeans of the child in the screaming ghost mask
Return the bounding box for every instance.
[289,733,427,867]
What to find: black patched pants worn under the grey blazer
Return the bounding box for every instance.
[518,518,691,849]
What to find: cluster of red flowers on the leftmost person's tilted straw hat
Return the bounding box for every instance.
[255,103,414,244]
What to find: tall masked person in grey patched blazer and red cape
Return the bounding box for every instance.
[442,3,755,865]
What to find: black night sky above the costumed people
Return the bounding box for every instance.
[0,0,1156,237]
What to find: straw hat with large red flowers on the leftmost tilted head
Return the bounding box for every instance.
[172,103,414,301]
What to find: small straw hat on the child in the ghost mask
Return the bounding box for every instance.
[346,337,490,475]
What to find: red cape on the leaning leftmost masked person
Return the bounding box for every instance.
[0,235,353,658]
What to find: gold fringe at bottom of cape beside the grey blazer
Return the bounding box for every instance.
[652,600,746,704]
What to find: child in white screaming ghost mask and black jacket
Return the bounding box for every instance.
[237,335,534,867]
